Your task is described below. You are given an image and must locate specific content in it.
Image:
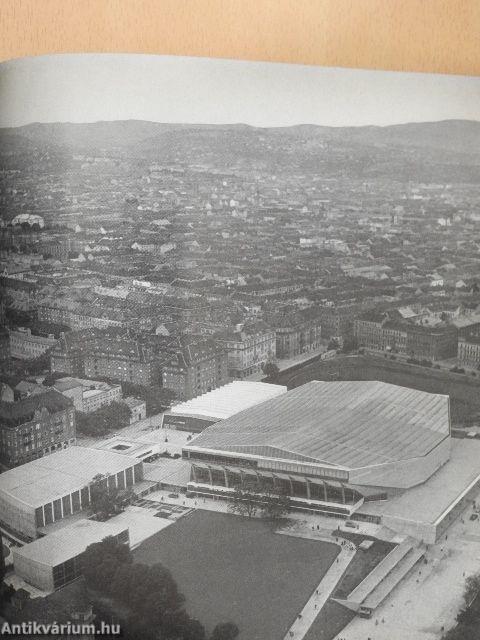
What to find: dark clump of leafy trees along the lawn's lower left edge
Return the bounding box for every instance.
[82,537,239,640]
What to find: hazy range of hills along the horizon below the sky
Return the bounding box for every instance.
[0,120,480,183]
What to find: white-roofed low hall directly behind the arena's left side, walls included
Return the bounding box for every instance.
[162,380,287,433]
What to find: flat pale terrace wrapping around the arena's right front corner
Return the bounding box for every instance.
[357,438,480,524]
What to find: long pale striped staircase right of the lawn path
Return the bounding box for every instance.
[338,538,425,617]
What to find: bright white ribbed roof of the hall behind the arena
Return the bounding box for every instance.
[168,381,287,420]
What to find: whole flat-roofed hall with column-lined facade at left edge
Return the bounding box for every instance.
[0,447,143,539]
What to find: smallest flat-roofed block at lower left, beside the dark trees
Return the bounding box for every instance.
[13,519,129,592]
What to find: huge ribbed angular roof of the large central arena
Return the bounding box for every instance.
[185,381,450,469]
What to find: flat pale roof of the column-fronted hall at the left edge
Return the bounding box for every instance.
[0,447,139,507]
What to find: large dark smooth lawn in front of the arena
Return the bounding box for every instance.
[134,511,339,640]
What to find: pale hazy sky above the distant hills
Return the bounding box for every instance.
[0,54,480,126]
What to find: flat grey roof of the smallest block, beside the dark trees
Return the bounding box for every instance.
[14,519,127,567]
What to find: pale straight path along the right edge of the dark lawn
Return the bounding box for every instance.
[284,544,356,640]
